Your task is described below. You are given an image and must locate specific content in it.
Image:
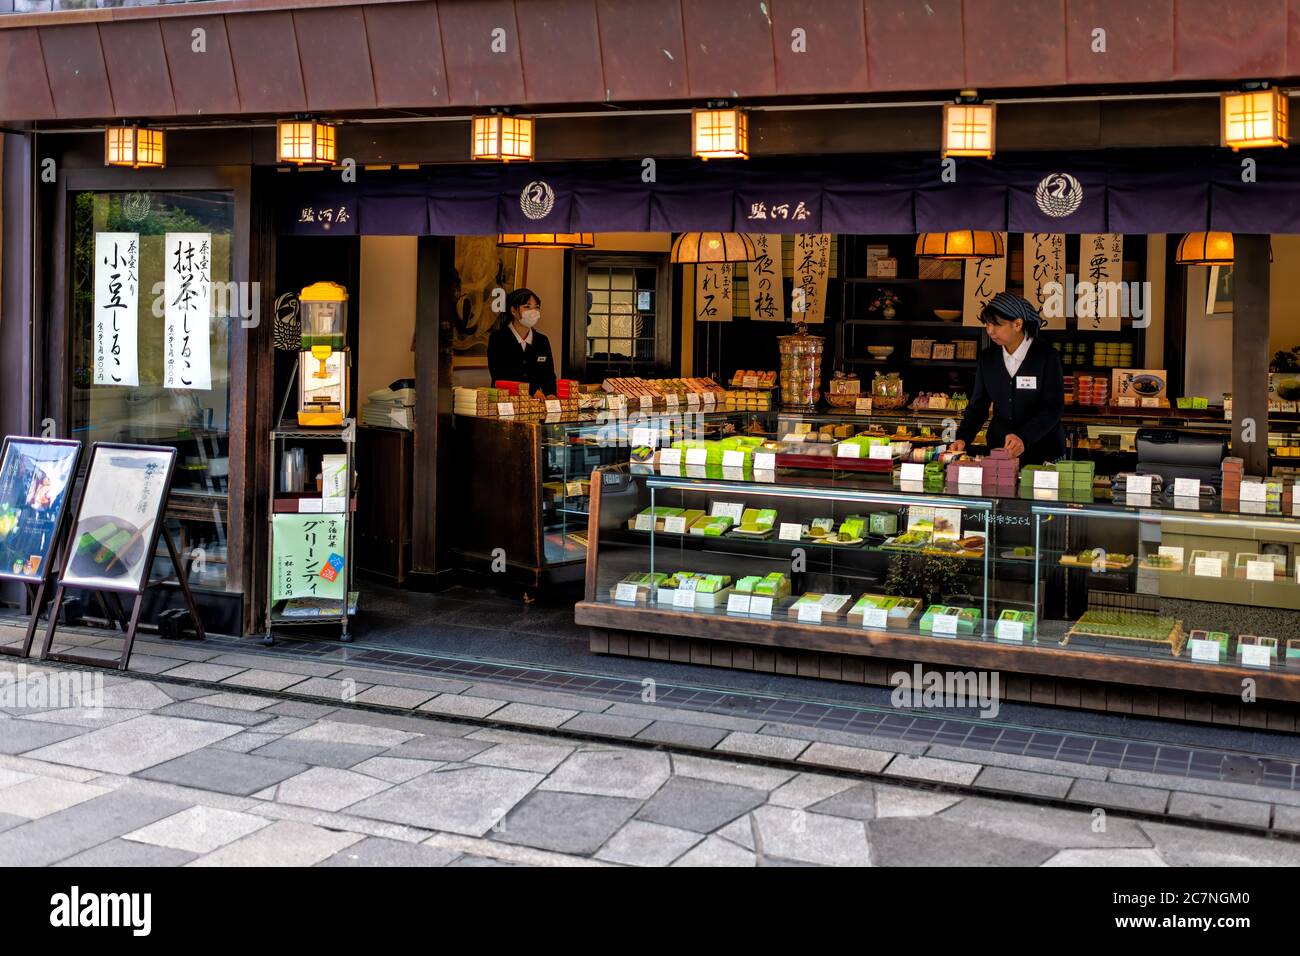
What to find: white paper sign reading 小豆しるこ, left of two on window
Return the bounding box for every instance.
[94,233,140,385]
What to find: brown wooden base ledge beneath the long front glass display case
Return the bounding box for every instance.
[575,601,1300,704]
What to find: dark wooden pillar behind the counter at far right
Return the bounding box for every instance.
[1227,233,1271,475]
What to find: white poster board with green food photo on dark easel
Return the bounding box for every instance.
[60,442,176,593]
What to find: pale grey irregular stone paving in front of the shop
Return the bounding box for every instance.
[0,646,1300,866]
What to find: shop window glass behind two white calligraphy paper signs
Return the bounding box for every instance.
[68,191,237,591]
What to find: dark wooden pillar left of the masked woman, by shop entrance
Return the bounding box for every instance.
[411,235,456,589]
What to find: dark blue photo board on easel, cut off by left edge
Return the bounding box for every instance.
[0,436,81,584]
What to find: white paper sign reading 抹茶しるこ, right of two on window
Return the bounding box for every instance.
[163,233,212,390]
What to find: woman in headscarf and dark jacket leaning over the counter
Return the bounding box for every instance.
[948,293,1065,464]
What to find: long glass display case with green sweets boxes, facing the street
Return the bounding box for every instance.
[576,437,1300,701]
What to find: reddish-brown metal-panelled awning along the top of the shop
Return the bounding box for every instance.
[0,0,1300,122]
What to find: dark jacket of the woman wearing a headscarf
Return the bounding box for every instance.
[957,337,1065,464]
